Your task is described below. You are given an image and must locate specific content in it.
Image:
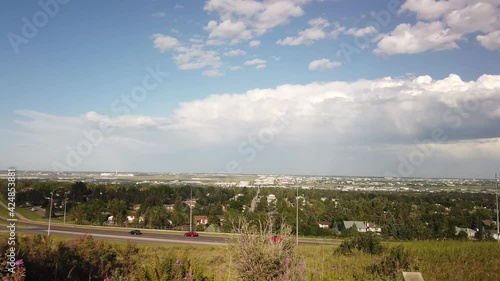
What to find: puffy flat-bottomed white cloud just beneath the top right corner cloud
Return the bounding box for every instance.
[374,21,461,55]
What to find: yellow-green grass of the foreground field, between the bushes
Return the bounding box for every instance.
[7,232,500,281]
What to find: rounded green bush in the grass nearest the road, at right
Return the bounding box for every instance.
[337,232,384,255]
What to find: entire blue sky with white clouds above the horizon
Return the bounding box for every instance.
[0,0,500,178]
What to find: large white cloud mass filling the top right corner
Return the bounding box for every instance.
[374,0,500,55]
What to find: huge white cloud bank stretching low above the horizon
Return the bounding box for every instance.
[4,73,500,174]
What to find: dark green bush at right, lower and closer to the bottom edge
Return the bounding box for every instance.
[370,245,419,279]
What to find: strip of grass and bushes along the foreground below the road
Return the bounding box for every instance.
[0,234,500,281]
